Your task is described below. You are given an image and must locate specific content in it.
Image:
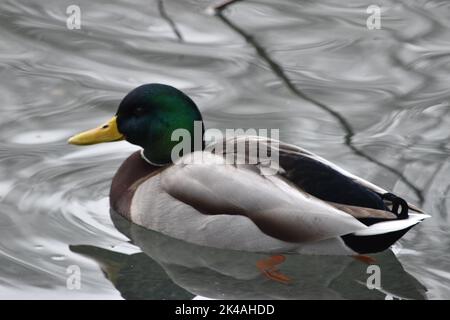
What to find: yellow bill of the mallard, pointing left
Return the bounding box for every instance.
[69,117,125,146]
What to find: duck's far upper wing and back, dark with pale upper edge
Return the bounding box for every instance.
[207,136,423,212]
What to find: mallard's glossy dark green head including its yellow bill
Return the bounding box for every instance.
[69,83,203,165]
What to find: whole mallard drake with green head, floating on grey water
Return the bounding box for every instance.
[69,84,429,255]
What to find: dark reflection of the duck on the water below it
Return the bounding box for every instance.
[71,212,425,299]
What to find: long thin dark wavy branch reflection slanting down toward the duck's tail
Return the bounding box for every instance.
[216,9,424,204]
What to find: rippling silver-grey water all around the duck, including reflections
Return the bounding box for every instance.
[0,0,450,299]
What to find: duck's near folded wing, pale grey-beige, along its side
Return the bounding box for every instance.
[161,152,367,242]
